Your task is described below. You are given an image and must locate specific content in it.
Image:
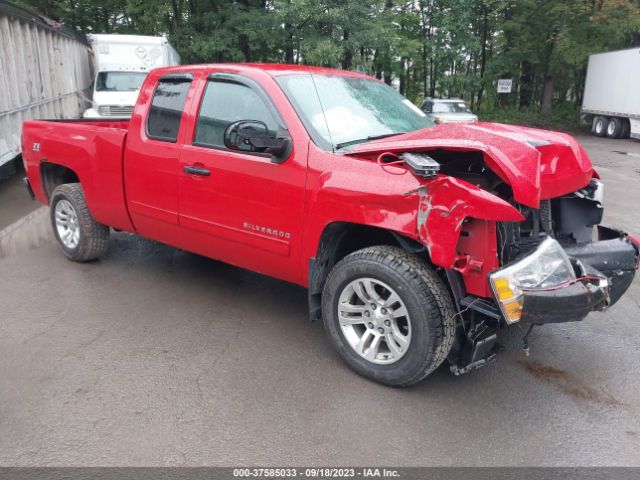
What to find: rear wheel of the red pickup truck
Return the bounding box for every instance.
[50,183,109,262]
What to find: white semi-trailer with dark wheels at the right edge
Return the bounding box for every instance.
[582,48,640,139]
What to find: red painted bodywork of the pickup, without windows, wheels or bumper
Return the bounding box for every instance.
[23,64,595,296]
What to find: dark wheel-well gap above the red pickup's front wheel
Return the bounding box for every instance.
[308,221,428,321]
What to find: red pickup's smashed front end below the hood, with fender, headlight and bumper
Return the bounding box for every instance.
[410,158,640,375]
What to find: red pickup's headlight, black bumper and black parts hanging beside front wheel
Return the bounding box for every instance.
[449,227,640,375]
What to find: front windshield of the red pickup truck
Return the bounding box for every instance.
[277,74,434,149]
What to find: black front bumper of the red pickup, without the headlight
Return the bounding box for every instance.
[504,226,640,324]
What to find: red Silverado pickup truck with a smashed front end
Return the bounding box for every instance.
[22,64,639,386]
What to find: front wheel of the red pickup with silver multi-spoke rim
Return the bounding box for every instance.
[322,246,455,387]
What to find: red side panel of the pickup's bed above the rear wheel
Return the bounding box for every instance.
[22,119,133,231]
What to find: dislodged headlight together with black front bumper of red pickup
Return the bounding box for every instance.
[489,227,638,324]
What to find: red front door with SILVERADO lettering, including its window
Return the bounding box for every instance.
[179,73,307,281]
